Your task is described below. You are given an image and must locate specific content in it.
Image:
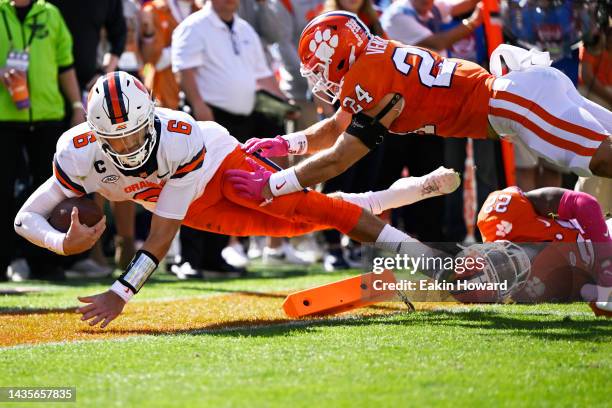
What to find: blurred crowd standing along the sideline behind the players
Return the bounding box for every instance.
[0,0,612,281]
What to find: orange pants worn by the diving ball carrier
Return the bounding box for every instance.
[183,146,362,237]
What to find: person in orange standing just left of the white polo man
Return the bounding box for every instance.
[141,0,200,109]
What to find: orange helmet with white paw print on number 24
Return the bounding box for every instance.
[298,11,371,104]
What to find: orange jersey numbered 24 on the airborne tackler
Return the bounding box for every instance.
[340,37,494,138]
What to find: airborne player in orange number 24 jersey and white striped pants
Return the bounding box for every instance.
[230,12,612,203]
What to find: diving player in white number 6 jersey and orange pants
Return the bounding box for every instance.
[15,72,459,327]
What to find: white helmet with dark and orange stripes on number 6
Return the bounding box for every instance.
[87,71,157,170]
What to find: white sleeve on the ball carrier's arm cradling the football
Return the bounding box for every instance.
[15,177,68,255]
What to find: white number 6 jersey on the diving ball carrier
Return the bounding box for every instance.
[53,108,238,219]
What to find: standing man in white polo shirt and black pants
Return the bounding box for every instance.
[171,0,282,276]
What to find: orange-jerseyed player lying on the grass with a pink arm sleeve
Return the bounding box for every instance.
[458,187,612,317]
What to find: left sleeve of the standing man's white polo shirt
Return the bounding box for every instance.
[172,24,206,72]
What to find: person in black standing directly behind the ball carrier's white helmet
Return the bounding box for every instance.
[50,0,137,278]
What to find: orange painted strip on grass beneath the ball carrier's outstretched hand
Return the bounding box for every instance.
[0,294,403,347]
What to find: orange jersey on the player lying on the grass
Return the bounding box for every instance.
[477,187,580,242]
